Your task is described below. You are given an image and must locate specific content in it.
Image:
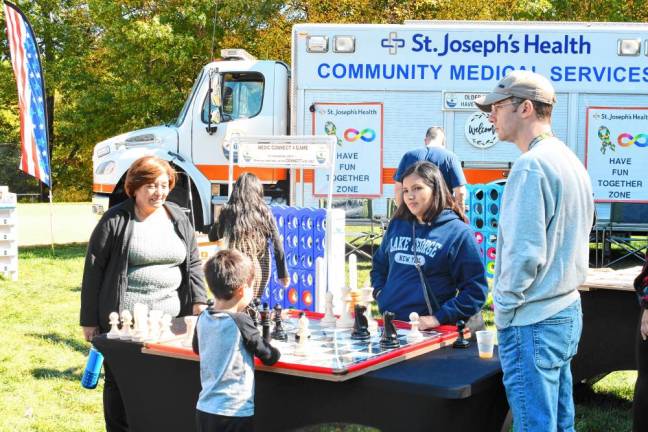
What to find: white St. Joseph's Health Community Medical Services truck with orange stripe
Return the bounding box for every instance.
[93,21,648,228]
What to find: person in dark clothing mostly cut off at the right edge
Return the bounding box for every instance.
[632,251,648,432]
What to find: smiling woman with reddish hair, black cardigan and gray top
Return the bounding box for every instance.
[81,156,207,431]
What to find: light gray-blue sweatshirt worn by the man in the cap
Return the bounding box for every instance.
[493,137,594,328]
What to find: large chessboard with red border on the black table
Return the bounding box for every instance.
[142,310,470,381]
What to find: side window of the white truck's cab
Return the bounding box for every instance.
[202,72,264,123]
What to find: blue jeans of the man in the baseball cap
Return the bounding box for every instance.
[497,299,583,432]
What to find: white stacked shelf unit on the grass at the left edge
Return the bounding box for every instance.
[0,186,18,281]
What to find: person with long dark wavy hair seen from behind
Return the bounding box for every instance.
[209,173,290,298]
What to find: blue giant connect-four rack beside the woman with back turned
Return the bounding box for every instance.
[261,206,326,312]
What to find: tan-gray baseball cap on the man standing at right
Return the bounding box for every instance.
[475,70,556,112]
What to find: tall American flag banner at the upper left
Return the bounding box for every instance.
[4,1,51,186]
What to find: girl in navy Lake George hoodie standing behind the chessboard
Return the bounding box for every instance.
[371,162,488,329]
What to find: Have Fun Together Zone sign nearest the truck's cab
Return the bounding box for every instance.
[313,102,383,198]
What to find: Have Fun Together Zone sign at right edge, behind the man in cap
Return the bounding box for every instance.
[585,107,648,203]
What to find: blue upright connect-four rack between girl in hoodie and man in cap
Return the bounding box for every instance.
[466,183,504,287]
